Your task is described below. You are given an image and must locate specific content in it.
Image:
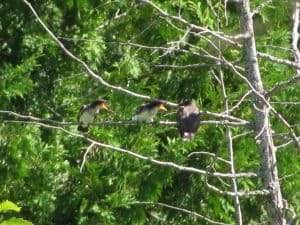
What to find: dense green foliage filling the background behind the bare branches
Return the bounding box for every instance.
[0,0,300,225]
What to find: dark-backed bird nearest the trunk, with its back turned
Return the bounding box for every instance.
[176,99,200,141]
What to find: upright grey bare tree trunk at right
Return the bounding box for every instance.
[240,0,286,225]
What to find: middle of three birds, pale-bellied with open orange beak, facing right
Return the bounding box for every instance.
[132,101,167,123]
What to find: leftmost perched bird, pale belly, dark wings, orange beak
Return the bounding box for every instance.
[77,100,108,132]
